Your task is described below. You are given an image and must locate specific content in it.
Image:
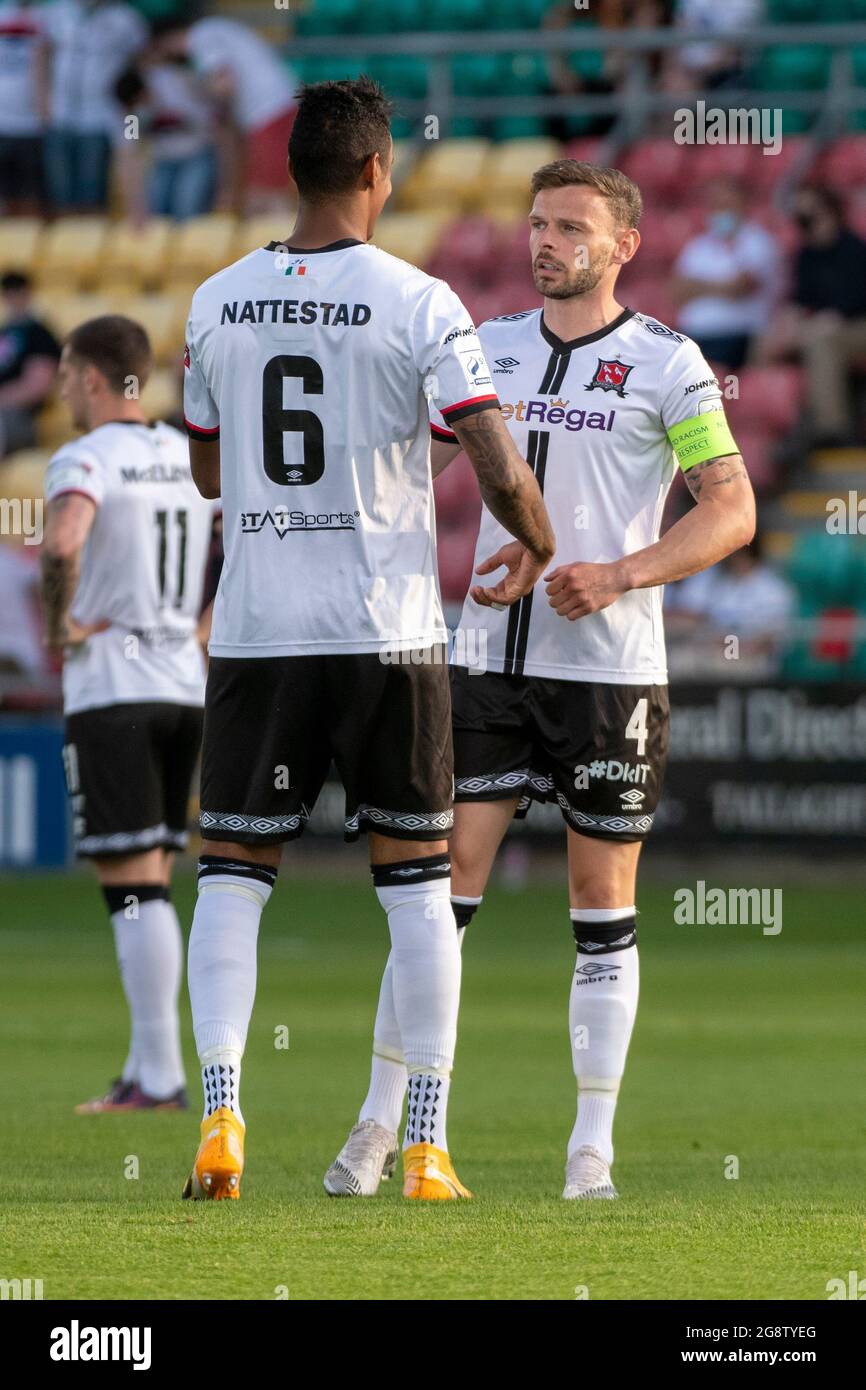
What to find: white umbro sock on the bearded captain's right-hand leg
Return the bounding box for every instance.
[569,906,639,1163]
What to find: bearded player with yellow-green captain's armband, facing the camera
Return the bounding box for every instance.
[335,160,755,1198]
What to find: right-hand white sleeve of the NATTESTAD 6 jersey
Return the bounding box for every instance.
[413,281,499,439]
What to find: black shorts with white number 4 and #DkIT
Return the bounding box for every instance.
[452,666,669,844]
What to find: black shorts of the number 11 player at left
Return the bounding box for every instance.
[63,701,202,859]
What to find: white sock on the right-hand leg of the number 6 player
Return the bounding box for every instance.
[373,855,460,1148]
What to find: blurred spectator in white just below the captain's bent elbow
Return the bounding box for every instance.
[664,535,796,656]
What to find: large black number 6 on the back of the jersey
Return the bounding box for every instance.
[261,356,325,488]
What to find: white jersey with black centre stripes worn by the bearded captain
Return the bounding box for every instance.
[431,309,737,685]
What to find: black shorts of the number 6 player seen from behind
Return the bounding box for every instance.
[200,646,453,845]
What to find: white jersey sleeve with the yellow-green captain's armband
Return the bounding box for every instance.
[659,338,740,473]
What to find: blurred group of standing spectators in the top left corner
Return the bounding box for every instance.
[0,0,295,222]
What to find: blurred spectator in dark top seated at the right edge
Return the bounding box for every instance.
[762,185,866,445]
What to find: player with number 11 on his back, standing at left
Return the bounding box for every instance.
[42,316,214,1115]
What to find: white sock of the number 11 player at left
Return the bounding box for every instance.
[111,885,183,1099]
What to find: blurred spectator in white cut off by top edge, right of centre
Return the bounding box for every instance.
[664,0,765,92]
